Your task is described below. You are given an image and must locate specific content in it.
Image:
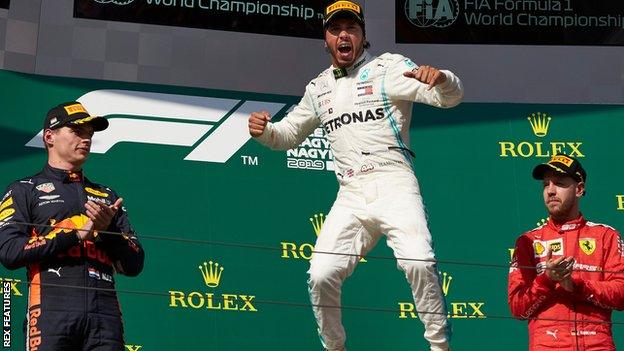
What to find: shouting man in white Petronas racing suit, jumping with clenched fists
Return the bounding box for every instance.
[249,1,463,351]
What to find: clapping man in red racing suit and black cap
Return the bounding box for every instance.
[508,155,624,351]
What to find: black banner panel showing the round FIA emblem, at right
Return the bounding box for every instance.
[395,0,624,46]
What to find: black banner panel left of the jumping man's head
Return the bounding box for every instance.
[74,0,323,38]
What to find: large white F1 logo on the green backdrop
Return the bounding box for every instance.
[26,90,286,163]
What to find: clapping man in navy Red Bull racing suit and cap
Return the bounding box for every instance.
[0,102,144,351]
